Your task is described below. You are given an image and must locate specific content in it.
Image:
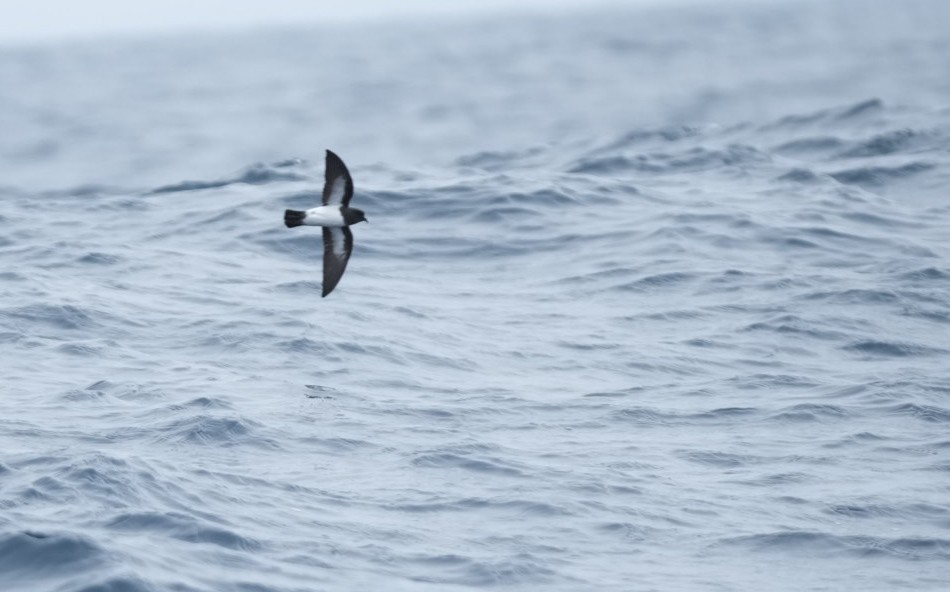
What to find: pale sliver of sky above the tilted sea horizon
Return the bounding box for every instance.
[0,0,648,44]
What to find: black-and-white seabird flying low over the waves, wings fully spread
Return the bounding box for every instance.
[284,150,369,297]
